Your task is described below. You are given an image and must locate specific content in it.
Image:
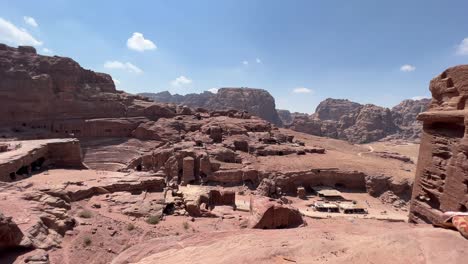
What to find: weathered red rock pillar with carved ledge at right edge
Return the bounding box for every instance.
[410,65,468,223]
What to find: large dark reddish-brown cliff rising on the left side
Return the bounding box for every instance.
[0,44,176,137]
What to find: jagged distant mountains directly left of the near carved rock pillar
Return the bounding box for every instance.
[289,98,428,143]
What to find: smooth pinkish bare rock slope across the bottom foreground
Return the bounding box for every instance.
[112,219,468,264]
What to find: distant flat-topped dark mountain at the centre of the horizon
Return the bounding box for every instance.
[140,88,282,125]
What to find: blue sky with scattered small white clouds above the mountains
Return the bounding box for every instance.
[0,0,468,113]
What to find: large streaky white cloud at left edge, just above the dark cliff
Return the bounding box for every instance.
[0,17,42,46]
